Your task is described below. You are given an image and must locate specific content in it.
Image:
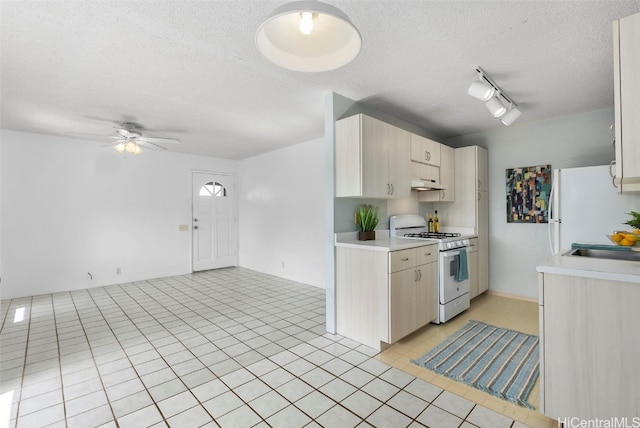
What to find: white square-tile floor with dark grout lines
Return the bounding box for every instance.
[0,268,556,428]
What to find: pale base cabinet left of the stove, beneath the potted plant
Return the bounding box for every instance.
[336,245,438,350]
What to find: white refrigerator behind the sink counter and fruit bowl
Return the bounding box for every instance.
[548,165,640,254]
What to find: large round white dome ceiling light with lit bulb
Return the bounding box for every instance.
[255,0,362,72]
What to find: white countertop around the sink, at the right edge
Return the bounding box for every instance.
[536,249,640,284]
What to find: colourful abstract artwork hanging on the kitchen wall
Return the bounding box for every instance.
[506,165,551,223]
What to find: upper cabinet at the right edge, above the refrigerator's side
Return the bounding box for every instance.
[613,13,640,192]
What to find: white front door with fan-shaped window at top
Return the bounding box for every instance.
[192,172,237,272]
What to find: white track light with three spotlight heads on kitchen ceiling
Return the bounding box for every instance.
[467,67,522,126]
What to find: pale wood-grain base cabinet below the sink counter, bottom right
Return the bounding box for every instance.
[539,273,640,420]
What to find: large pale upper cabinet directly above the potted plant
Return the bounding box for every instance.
[336,114,411,199]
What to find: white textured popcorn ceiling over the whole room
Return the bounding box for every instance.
[0,0,640,159]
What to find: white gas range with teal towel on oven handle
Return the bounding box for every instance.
[389,214,471,324]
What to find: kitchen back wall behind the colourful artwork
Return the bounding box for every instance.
[444,109,614,298]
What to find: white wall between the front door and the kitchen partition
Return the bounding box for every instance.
[238,139,330,288]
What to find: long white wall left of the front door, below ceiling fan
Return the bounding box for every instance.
[0,130,237,299]
